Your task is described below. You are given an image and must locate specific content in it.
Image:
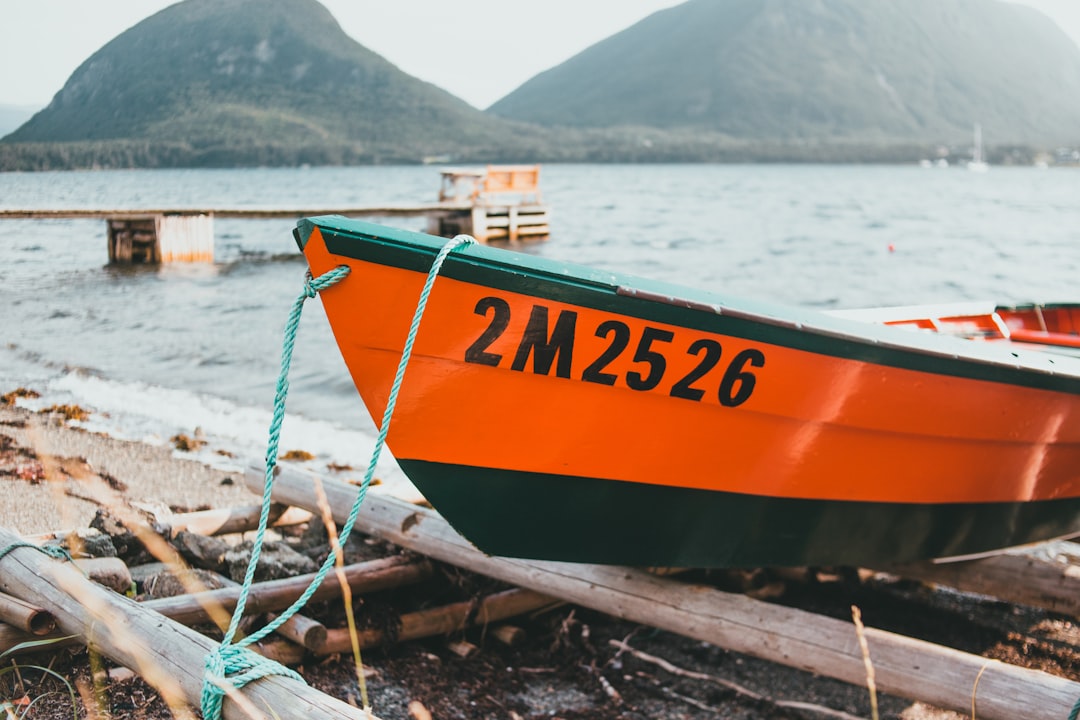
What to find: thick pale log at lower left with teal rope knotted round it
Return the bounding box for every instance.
[0,528,380,720]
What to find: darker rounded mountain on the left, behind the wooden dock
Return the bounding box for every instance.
[4,0,544,164]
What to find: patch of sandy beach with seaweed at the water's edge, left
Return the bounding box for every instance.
[0,406,258,534]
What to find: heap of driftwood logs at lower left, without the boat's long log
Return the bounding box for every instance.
[0,506,556,718]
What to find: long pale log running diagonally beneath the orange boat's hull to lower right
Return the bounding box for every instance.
[246,468,1080,720]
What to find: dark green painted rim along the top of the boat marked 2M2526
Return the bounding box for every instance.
[303,216,1080,394]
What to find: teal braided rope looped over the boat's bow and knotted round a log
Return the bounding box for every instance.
[202,235,476,720]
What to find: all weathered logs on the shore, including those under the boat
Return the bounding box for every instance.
[0,471,1080,719]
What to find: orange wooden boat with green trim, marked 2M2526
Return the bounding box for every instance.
[295,217,1080,567]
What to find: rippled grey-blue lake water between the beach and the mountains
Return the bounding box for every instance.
[0,165,1080,483]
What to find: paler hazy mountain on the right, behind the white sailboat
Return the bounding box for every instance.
[489,0,1080,146]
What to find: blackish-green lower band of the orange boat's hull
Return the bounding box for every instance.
[400,460,1080,568]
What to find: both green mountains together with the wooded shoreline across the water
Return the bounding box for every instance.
[0,0,1080,171]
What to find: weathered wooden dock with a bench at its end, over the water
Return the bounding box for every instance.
[0,165,550,263]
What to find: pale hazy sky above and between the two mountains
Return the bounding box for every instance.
[0,0,1080,109]
